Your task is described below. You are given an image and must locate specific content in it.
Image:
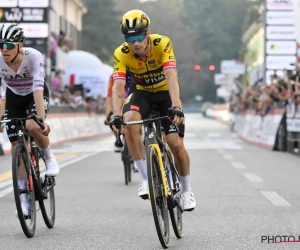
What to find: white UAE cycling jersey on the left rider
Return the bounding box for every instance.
[0,48,45,98]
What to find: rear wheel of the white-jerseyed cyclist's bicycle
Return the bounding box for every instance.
[35,150,55,229]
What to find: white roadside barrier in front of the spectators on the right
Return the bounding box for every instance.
[204,103,300,156]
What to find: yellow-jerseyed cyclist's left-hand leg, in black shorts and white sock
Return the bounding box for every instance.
[123,91,151,197]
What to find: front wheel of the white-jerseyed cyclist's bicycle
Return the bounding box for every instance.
[12,144,36,238]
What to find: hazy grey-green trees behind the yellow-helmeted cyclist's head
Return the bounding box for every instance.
[83,0,251,101]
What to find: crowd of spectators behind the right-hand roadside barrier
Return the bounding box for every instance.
[230,64,300,116]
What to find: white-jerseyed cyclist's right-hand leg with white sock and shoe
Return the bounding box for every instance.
[26,85,59,176]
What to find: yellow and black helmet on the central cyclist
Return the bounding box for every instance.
[120,10,150,36]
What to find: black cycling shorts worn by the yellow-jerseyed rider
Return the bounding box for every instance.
[123,90,183,135]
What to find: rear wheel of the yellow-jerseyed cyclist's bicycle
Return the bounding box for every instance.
[165,147,182,239]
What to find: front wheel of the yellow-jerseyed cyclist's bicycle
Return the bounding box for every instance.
[147,146,170,248]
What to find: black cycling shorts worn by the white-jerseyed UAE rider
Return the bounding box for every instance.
[5,85,49,142]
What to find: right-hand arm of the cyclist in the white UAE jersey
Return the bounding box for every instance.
[31,53,46,121]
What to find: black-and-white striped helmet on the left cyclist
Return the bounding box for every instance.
[0,23,25,43]
